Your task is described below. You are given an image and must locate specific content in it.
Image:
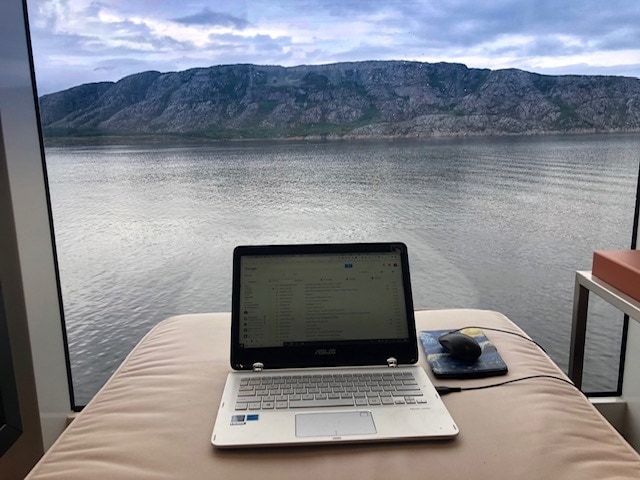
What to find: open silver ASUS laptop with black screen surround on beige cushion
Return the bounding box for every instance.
[211,243,458,447]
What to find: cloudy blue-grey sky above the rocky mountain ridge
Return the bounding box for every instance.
[27,0,640,94]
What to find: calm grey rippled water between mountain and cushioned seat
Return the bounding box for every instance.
[46,135,640,404]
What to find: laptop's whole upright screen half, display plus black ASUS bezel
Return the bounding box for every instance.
[232,243,417,369]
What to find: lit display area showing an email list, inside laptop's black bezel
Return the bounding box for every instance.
[239,252,408,348]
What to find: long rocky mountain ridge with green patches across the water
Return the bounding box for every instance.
[40,61,640,138]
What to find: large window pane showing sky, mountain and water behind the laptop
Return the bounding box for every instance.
[29,0,640,404]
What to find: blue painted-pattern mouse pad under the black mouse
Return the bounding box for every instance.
[420,328,507,378]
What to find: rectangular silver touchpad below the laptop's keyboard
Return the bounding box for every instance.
[296,411,377,437]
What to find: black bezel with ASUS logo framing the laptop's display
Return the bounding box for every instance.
[231,242,418,370]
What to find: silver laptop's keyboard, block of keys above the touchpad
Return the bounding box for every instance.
[235,371,427,410]
